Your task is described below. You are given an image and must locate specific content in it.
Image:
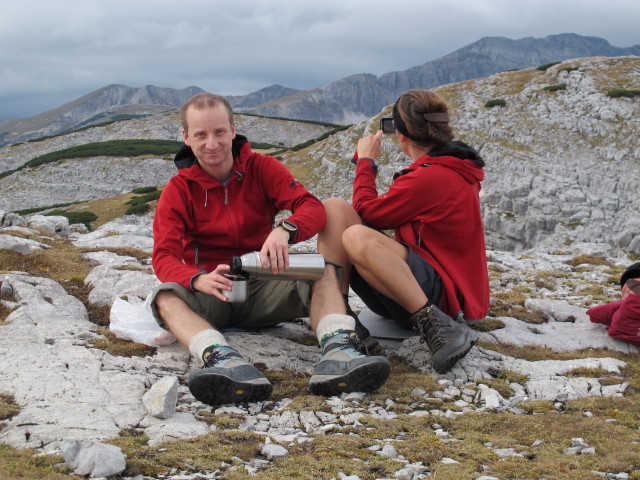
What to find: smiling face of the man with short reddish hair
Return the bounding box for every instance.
[182,104,236,178]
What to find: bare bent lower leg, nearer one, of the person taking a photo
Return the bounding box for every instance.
[342,225,428,312]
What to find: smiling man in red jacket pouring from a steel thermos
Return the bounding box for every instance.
[152,93,390,405]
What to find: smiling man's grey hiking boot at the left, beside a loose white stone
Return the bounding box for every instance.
[188,345,273,405]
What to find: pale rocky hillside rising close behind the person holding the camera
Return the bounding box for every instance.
[283,57,640,260]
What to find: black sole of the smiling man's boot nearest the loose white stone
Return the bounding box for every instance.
[189,372,273,405]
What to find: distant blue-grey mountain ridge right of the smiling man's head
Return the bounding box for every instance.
[242,33,640,125]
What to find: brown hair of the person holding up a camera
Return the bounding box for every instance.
[393,89,454,146]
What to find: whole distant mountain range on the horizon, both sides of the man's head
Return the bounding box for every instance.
[0,34,640,146]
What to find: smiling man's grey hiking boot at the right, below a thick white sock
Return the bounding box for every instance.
[309,330,391,397]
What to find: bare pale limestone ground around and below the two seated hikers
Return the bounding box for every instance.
[0,214,640,480]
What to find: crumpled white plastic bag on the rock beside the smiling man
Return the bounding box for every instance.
[109,295,176,347]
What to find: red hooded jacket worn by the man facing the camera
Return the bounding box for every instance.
[152,135,326,288]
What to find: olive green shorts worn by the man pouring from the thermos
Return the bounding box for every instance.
[151,279,313,330]
